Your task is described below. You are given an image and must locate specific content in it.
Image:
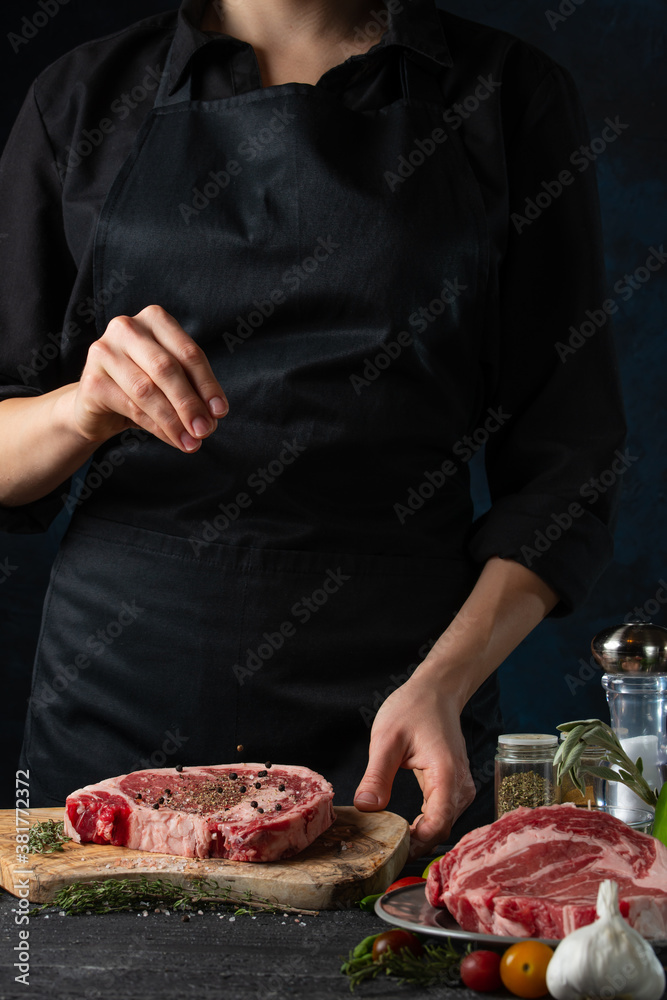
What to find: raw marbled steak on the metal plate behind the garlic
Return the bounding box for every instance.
[426,805,667,939]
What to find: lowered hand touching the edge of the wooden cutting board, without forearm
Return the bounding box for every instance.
[354,669,475,858]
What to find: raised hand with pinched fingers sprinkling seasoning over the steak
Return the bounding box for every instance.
[72,305,229,453]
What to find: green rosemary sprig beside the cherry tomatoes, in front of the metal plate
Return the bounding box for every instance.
[340,938,472,991]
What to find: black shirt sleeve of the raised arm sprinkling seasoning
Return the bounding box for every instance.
[0,84,76,533]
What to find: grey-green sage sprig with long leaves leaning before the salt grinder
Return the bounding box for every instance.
[554,719,658,807]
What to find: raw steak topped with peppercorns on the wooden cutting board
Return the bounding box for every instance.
[65,764,335,861]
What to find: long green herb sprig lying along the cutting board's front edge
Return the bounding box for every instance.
[32,875,317,916]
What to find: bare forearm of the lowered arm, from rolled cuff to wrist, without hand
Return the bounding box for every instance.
[415,556,559,709]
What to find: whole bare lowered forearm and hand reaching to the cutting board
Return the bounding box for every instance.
[354,556,558,857]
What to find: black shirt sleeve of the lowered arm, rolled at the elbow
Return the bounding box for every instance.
[471,64,633,616]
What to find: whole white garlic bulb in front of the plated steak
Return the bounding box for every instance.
[547,880,665,1000]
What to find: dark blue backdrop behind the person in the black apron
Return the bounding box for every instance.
[0,0,667,806]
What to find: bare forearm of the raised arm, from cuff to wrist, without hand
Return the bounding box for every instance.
[0,385,100,507]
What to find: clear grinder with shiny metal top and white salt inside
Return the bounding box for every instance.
[591,622,667,809]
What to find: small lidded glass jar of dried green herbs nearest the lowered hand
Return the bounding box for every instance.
[495,733,558,819]
